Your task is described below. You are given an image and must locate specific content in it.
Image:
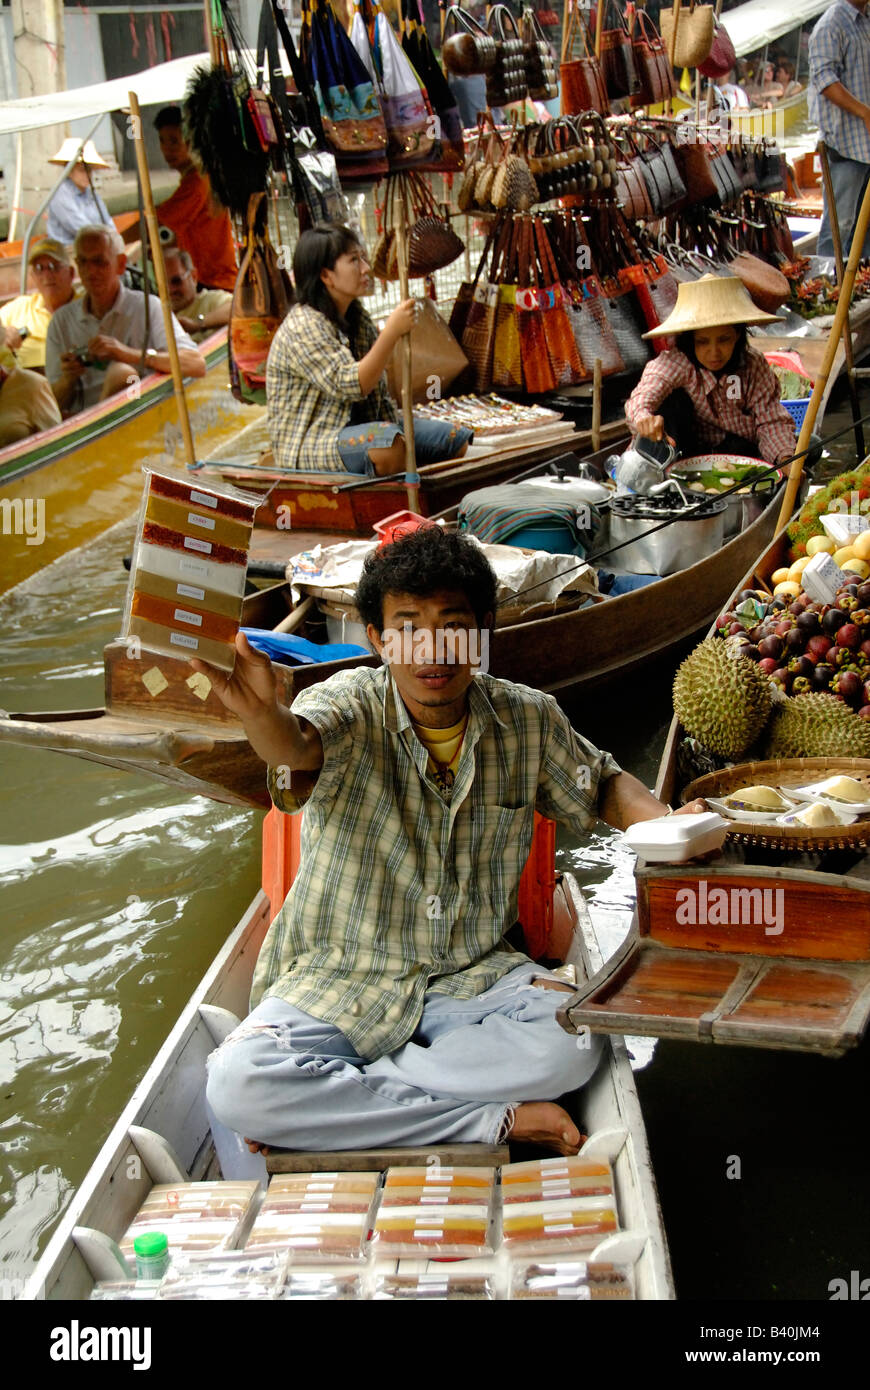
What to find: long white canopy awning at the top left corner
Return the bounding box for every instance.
[0,53,210,136]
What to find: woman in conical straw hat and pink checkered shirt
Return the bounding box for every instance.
[625,275,795,463]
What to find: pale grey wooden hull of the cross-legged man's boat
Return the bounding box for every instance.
[24,878,674,1300]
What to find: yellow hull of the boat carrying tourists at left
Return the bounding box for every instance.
[0,329,258,594]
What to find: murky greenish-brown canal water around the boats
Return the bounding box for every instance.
[0,394,870,1300]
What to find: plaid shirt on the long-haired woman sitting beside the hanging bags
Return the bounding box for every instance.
[265,304,397,473]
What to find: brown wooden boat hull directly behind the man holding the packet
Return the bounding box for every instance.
[0,483,780,806]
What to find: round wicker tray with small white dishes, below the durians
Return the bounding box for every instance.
[680,758,870,852]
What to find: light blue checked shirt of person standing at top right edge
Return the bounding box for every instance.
[809,0,870,162]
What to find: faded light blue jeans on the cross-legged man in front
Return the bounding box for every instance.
[207,960,603,1150]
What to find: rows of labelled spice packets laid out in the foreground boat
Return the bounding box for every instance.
[95,1156,634,1301]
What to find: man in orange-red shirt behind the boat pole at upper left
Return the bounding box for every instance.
[154,106,238,291]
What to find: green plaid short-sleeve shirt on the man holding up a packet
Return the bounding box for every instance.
[252,666,620,1059]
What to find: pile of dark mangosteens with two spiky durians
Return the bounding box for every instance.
[674,581,870,759]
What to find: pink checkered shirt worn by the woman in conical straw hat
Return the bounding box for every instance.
[625,348,795,463]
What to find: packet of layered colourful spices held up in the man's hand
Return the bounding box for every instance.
[121,470,260,671]
